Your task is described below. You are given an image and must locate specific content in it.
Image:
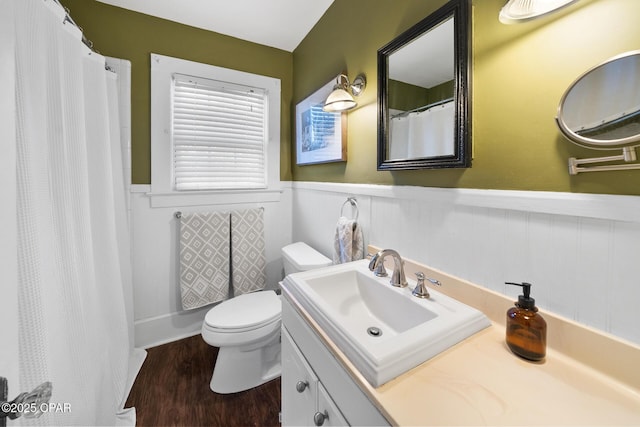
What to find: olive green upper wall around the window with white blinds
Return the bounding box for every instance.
[62,0,293,184]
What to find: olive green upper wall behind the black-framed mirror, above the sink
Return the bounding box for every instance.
[292,0,640,195]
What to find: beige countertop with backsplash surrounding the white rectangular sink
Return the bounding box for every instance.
[285,247,640,426]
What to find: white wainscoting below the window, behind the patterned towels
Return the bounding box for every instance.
[131,185,291,348]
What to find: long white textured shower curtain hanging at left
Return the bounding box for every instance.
[10,0,135,425]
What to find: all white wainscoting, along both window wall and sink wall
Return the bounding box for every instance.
[131,182,640,348]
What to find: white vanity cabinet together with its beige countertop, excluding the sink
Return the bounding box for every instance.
[282,248,640,426]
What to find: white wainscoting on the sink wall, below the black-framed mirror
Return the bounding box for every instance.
[291,182,640,344]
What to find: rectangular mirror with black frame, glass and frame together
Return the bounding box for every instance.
[378,0,471,170]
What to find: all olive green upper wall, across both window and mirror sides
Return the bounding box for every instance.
[62,0,640,195]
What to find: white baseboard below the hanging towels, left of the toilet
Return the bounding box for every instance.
[134,307,211,349]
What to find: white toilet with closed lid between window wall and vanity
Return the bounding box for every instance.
[202,242,332,394]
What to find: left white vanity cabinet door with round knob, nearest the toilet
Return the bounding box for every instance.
[281,328,318,426]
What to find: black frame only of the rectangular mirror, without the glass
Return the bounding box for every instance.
[378,0,471,170]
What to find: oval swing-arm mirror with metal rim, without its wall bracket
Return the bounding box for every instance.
[556,51,640,150]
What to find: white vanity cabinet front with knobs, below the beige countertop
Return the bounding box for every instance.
[281,298,389,426]
